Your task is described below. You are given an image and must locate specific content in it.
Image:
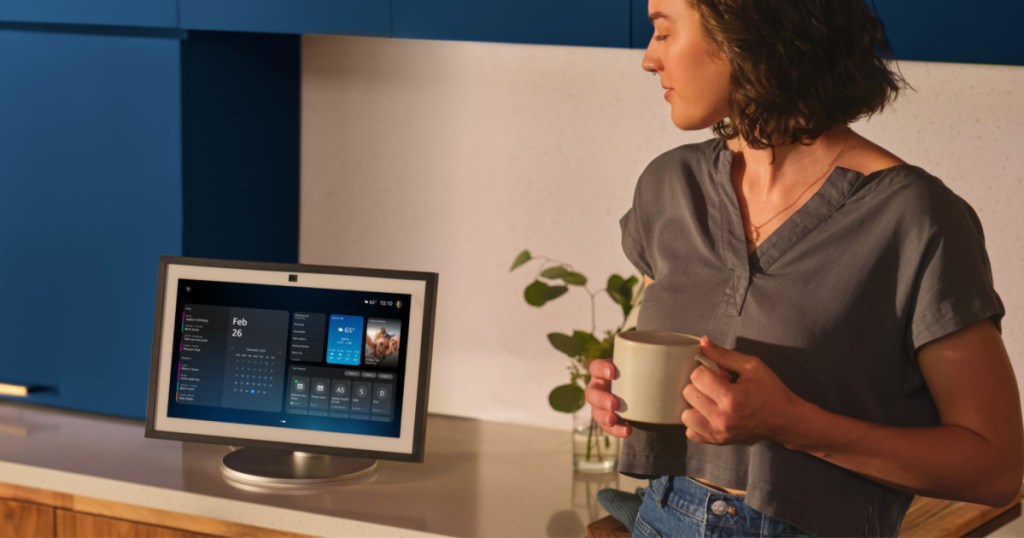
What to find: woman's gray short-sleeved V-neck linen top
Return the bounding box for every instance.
[620,138,1004,536]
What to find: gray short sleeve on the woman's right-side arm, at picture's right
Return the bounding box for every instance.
[910,193,1006,349]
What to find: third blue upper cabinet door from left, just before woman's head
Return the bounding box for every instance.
[391,0,630,47]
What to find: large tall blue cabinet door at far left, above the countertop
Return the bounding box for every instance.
[0,29,182,417]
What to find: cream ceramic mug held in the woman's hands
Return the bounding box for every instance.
[611,331,718,424]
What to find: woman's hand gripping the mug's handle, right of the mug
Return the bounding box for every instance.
[682,336,800,445]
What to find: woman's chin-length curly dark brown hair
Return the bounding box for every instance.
[688,0,908,149]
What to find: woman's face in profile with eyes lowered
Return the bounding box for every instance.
[643,0,730,130]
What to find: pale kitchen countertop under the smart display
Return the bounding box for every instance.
[0,401,642,536]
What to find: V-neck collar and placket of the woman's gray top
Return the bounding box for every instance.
[710,138,864,316]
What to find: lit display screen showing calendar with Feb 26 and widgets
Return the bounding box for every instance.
[168,280,411,437]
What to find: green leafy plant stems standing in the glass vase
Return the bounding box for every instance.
[509,250,643,413]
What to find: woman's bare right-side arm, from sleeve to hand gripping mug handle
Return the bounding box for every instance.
[683,321,1024,505]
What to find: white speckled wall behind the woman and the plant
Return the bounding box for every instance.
[300,36,1024,428]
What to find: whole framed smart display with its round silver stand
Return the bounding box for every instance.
[145,256,437,487]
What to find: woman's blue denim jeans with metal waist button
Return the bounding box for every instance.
[633,477,811,537]
